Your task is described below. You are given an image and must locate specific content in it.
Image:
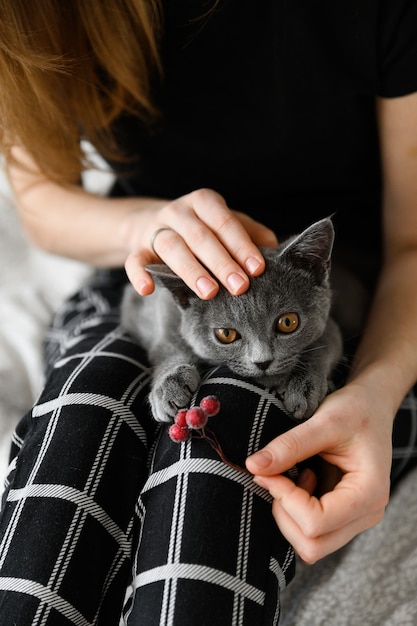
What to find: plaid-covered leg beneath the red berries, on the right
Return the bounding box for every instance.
[125,369,296,626]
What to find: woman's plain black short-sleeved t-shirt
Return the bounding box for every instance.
[108,0,417,276]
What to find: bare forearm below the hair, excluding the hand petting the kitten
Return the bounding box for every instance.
[8,152,166,267]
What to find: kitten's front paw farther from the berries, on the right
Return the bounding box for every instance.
[279,375,327,420]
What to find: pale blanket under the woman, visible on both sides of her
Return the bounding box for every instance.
[0,168,417,626]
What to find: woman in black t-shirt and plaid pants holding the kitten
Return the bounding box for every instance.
[0,0,417,625]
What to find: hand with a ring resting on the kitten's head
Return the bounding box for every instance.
[125,189,277,299]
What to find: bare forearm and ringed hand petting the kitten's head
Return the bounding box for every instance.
[9,146,277,299]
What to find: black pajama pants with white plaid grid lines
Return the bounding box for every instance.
[0,271,417,626]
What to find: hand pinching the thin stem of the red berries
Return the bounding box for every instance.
[247,383,392,563]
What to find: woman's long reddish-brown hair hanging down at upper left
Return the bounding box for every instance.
[0,0,161,182]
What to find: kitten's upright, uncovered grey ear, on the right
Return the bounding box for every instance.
[282,217,334,280]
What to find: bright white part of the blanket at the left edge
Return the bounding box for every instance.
[0,170,95,484]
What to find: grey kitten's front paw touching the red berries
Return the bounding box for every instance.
[149,365,200,422]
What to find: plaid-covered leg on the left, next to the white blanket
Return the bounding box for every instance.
[0,272,155,626]
